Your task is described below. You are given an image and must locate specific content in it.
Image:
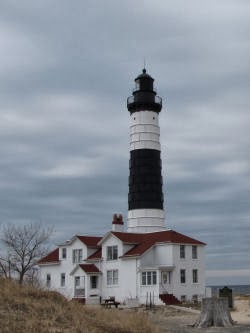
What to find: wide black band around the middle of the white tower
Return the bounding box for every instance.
[128,149,163,210]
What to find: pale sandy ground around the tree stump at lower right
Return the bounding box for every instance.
[146,299,250,333]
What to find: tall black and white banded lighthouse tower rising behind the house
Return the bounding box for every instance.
[127,68,166,233]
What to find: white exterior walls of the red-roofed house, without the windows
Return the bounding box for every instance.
[40,234,205,304]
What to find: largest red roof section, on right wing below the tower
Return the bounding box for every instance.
[112,230,205,257]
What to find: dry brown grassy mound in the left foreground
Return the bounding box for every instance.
[0,279,157,333]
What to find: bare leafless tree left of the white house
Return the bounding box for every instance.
[0,223,52,284]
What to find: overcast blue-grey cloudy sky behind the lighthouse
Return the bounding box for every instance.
[0,0,250,284]
